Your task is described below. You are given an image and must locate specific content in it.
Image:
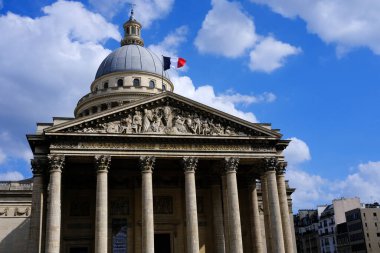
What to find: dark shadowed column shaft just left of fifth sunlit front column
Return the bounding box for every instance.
[211,184,226,253]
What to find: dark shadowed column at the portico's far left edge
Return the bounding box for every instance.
[28,159,43,253]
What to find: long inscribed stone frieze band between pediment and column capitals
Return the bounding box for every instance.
[50,142,275,152]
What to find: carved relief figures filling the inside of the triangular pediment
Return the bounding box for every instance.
[66,102,255,136]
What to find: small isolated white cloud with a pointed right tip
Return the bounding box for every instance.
[249,37,301,73]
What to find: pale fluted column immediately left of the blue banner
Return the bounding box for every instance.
[95,155,111,253]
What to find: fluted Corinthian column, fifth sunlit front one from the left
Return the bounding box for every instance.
[225,157,243,253]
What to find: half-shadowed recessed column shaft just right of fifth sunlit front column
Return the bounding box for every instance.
[250,180,264,253]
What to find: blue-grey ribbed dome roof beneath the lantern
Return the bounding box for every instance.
[95,44,169,79]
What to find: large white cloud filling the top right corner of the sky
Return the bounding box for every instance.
[251,0,380,54]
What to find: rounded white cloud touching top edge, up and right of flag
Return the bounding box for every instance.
[195,0,257,58]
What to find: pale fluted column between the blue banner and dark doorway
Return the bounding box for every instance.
[140,156,156,253]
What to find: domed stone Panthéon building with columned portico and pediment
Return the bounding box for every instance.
[0,12,296,253]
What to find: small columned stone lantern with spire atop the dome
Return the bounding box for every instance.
[120,8,144,47]
